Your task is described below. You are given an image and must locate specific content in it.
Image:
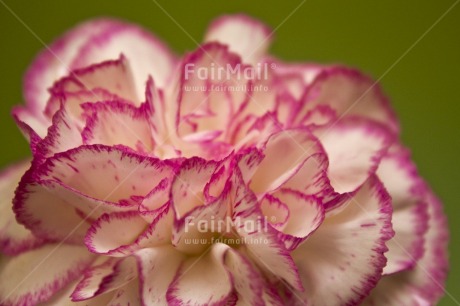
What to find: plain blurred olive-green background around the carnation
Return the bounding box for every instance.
[0,0,460,306]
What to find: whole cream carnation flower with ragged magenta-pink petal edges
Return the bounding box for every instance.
[0,15,447,305]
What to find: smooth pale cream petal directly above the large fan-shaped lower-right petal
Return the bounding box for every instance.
[315,119,394,193]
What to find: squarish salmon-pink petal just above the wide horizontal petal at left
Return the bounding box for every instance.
[81,101,154,153]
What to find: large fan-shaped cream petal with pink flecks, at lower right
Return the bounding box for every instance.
[288,176,393,305]
